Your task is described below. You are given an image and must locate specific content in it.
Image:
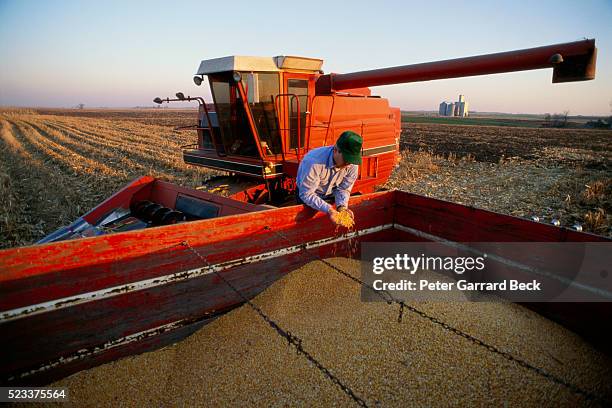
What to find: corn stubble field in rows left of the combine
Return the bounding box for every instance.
[0,110,214,248]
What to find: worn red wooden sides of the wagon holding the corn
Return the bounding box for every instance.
[0,179,611,385]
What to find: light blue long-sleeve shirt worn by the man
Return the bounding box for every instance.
[297,146,359,213]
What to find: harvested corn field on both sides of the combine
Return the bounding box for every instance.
[0,109,612,248]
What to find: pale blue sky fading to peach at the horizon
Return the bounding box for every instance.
[0,0,612,115]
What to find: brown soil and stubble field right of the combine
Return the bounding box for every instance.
[385,123,612,236]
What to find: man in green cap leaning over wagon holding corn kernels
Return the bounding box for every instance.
[296,130,363,224]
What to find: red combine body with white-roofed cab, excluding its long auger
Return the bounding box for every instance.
[161,56,401,206]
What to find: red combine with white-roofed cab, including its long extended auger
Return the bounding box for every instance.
[170,40,596,205]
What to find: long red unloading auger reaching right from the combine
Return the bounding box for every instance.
[317,39,597,93]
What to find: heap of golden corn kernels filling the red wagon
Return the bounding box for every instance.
[45,258,612,406]
